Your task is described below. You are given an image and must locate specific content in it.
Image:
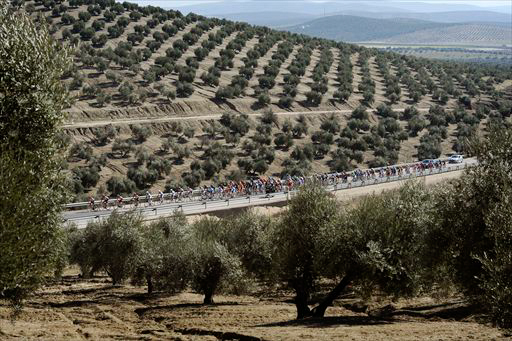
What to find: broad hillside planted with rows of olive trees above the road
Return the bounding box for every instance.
[16,0,512,200]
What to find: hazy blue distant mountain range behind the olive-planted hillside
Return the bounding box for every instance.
[173,0,512,46]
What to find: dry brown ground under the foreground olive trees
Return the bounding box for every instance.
[0,269,506,340]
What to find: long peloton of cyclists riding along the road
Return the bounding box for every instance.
[89,160,446,210]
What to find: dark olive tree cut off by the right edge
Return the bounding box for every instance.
[429,127,512,327]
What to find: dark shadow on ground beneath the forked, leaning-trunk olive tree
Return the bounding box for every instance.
[253,316,397,328]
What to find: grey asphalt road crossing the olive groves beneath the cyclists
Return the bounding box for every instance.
[62,159,476,228]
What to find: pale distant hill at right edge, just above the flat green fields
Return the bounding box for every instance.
[372,24,512,46]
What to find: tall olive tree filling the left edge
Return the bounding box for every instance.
[0,0,70,306]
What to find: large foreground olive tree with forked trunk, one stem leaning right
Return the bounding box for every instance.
[274,183,434,318]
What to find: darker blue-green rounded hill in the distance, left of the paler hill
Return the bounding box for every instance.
[286,15,449,42]
